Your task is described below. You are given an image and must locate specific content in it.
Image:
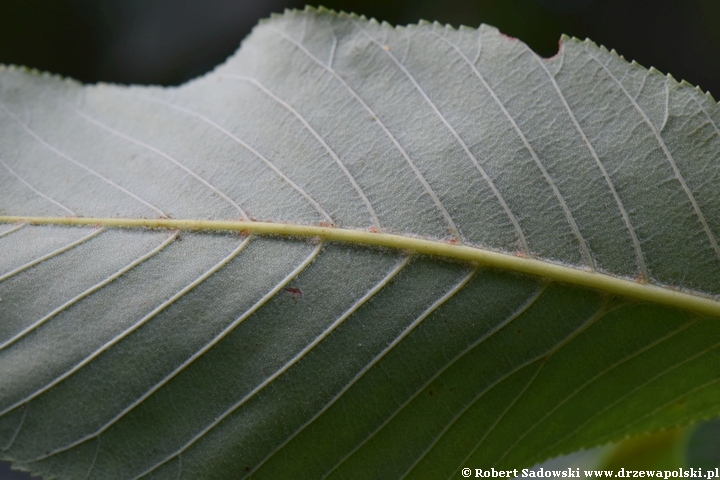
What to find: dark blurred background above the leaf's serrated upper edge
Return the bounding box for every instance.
[0,0,720,479]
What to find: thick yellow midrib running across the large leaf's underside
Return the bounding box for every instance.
[0,216,720,316]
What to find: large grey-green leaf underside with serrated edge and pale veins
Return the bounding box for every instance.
[0,5,720,478]
